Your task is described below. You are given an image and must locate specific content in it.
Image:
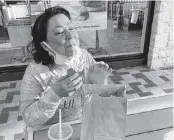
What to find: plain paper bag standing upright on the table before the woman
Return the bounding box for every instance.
[81,88,127,140]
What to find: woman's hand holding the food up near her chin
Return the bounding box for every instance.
[52,69,83,98]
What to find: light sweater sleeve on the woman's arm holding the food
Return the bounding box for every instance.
[20,65,60,127]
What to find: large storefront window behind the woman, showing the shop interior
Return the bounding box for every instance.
[0,0,148,65]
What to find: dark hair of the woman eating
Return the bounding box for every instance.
[28,6,71,65]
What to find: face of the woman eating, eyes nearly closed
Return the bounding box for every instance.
[46,14,79,57]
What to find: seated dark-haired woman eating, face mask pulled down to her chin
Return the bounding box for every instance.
[20,6,121,127]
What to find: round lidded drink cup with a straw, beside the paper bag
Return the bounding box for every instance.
[48,123,73,140]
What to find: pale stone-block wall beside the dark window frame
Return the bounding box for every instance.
[147,0,174,69]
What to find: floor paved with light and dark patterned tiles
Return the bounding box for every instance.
[0,66,173,140]
